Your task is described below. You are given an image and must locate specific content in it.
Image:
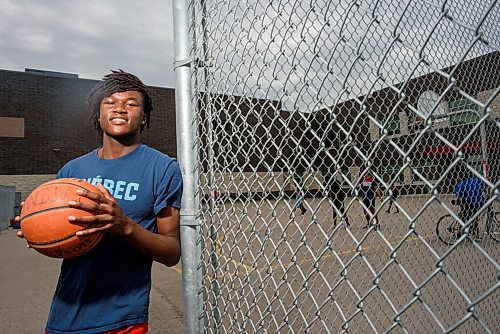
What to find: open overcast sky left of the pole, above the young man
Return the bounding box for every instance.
[0,0,175,87]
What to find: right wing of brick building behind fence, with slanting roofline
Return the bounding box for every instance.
[308,52,500,194]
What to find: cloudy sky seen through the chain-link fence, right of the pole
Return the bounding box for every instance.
[190,0,500,112]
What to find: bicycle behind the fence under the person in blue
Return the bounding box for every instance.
[436,201,500,245]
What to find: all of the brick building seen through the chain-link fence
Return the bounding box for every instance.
[200,52,500,197]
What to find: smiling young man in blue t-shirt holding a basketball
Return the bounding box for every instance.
[16,70,182,334]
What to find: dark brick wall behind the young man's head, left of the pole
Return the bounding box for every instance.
[0,70,176,175]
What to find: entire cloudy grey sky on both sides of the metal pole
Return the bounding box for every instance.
[0,0,500,111]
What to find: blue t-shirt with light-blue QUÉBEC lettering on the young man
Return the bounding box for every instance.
[46,144,182,334]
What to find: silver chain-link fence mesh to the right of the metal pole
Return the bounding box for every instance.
[174,0,500,333]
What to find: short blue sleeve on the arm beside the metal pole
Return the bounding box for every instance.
[154,160,182,214]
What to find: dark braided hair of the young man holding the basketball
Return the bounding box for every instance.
[87,69,153,134]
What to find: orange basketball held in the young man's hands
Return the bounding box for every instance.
[20,178,103,259]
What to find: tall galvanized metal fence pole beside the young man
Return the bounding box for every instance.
[172,0,203,333]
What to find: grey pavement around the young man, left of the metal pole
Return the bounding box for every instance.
[0,228,184,334]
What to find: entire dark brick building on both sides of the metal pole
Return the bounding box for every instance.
[0,52,500,198]
